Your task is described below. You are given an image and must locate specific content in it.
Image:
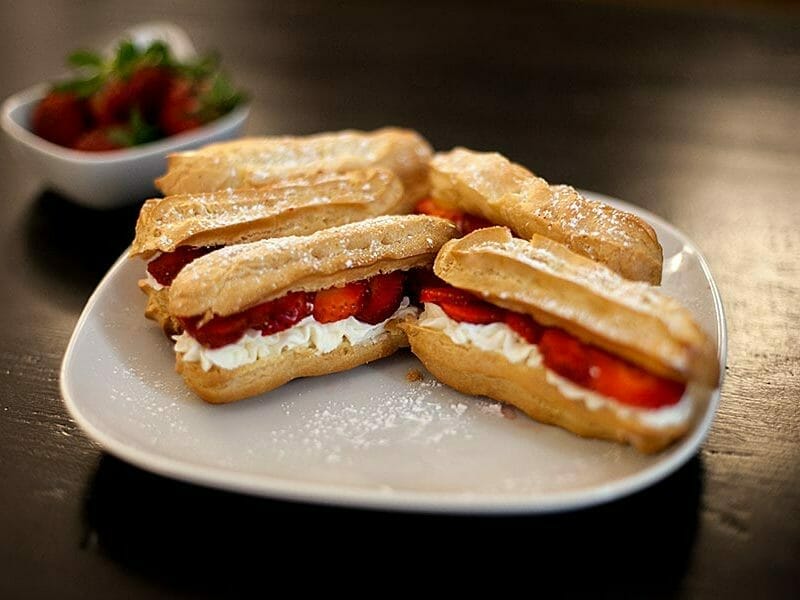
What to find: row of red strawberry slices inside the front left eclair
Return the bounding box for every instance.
[180,271,407,348]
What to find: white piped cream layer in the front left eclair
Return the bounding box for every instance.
[173,298,419,371]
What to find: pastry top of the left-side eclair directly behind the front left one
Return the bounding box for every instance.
[130,169,403,258]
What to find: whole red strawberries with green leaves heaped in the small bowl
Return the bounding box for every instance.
[31,40,243,152]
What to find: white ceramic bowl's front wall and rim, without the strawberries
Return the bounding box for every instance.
[0,84,250,208]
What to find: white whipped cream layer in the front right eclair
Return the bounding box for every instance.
[417,303,692,429]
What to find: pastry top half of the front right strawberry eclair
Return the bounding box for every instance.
[434,227,719,387]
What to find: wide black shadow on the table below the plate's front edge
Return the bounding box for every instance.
[85,455,703,597]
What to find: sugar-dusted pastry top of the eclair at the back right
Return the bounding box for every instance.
[430,148,662,284]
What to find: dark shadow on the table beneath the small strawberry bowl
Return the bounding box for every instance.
[22,190,140,310]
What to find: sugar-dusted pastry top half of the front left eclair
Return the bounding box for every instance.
[169,215,457,318]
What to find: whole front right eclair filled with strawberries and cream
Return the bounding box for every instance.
[402,227,719,452]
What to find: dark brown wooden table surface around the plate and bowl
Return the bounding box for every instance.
[0,0,800,598]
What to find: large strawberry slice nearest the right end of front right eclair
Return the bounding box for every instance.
[589,348,686,408]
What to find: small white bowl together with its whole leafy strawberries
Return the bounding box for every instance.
[0,23,249,209]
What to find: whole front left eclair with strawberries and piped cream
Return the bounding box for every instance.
[168,215,456,403]
